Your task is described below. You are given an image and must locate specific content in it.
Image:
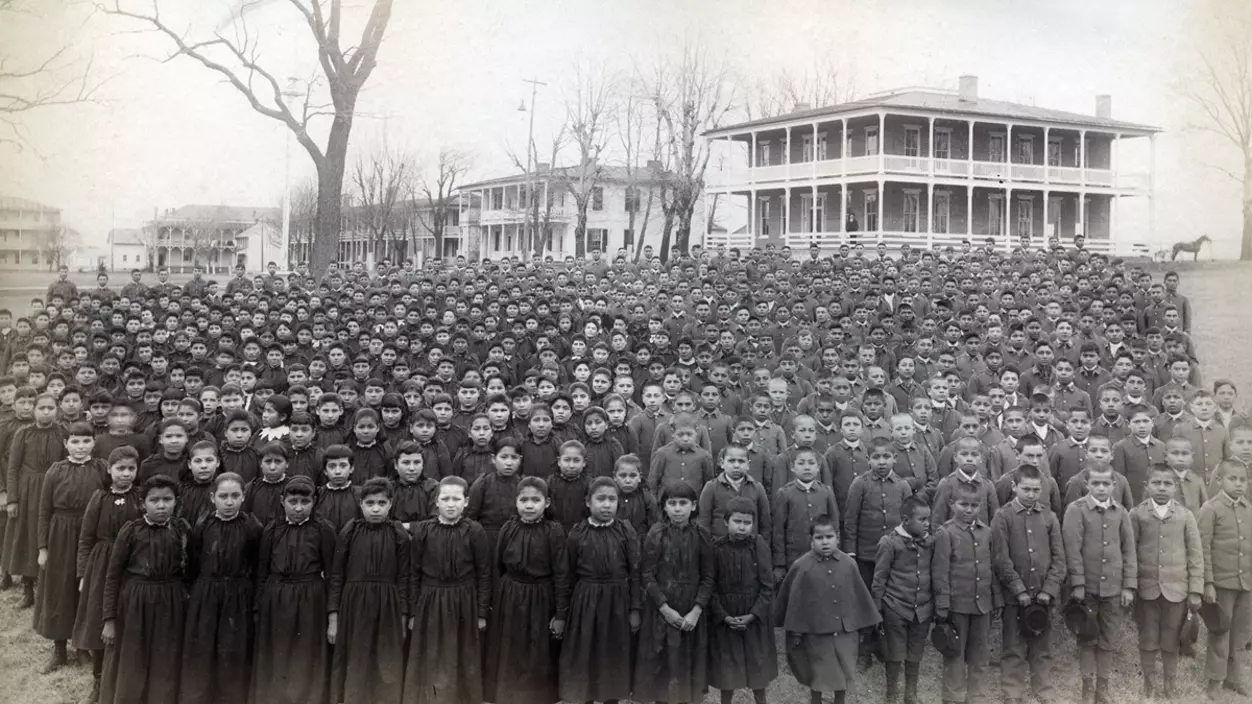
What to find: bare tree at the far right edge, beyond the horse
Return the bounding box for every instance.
[1179,3,1252,262]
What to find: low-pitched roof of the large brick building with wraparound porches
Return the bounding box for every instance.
[705,90,1161,137]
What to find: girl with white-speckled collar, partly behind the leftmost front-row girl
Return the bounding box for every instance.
[74,447,143,701]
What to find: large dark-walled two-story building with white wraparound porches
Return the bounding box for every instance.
[705,75,1159,252]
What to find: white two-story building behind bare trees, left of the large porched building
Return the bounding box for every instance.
[461,163,702,259]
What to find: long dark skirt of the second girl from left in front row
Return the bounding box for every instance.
[178,579,254,704]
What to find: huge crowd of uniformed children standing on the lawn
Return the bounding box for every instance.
[0,243,1252,704]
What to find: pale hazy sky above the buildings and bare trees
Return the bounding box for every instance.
[0,0,1239,257]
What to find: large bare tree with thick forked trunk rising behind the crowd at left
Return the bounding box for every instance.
[104,0,393,272]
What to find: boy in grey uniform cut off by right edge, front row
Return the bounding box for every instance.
[1196,460,1252,699]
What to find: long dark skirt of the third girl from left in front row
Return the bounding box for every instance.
[250,577,331,704]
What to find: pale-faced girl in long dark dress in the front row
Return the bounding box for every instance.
[403,476,491,704]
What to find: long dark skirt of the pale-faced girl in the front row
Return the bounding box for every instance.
[404,580,482,704]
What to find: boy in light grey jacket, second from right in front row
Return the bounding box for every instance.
[1131,465,1204,699]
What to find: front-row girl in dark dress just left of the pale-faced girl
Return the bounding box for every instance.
[327,477,412,704]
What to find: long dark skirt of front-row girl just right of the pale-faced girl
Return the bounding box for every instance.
[483,576,561,704]
